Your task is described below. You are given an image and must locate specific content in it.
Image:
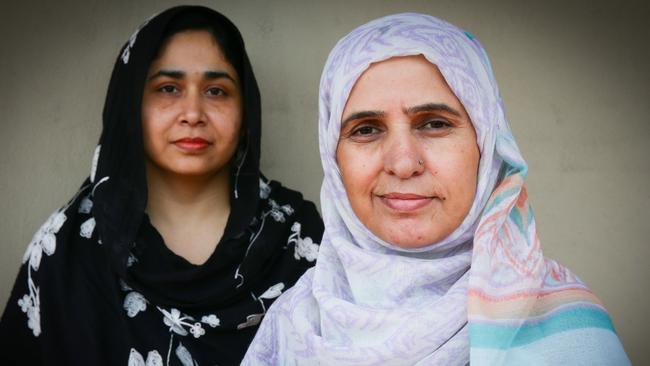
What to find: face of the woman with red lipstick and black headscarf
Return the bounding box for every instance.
[142,31,242,176]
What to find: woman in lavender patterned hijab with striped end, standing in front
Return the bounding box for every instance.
[244,14,629,365]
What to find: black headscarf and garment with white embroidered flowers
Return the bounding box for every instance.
[0,6,323,365]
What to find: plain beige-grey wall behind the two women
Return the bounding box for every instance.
[0,0,650,364]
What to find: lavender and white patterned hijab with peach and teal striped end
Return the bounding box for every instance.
[243,13,626,365]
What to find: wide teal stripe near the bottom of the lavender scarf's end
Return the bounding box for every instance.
[469,307,616,349]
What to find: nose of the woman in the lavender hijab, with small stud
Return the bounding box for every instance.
[384,132,424,179]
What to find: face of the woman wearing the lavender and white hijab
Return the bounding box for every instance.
[336,56,480,248]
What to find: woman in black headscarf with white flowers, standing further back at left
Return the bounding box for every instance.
[0,7,323,365]
